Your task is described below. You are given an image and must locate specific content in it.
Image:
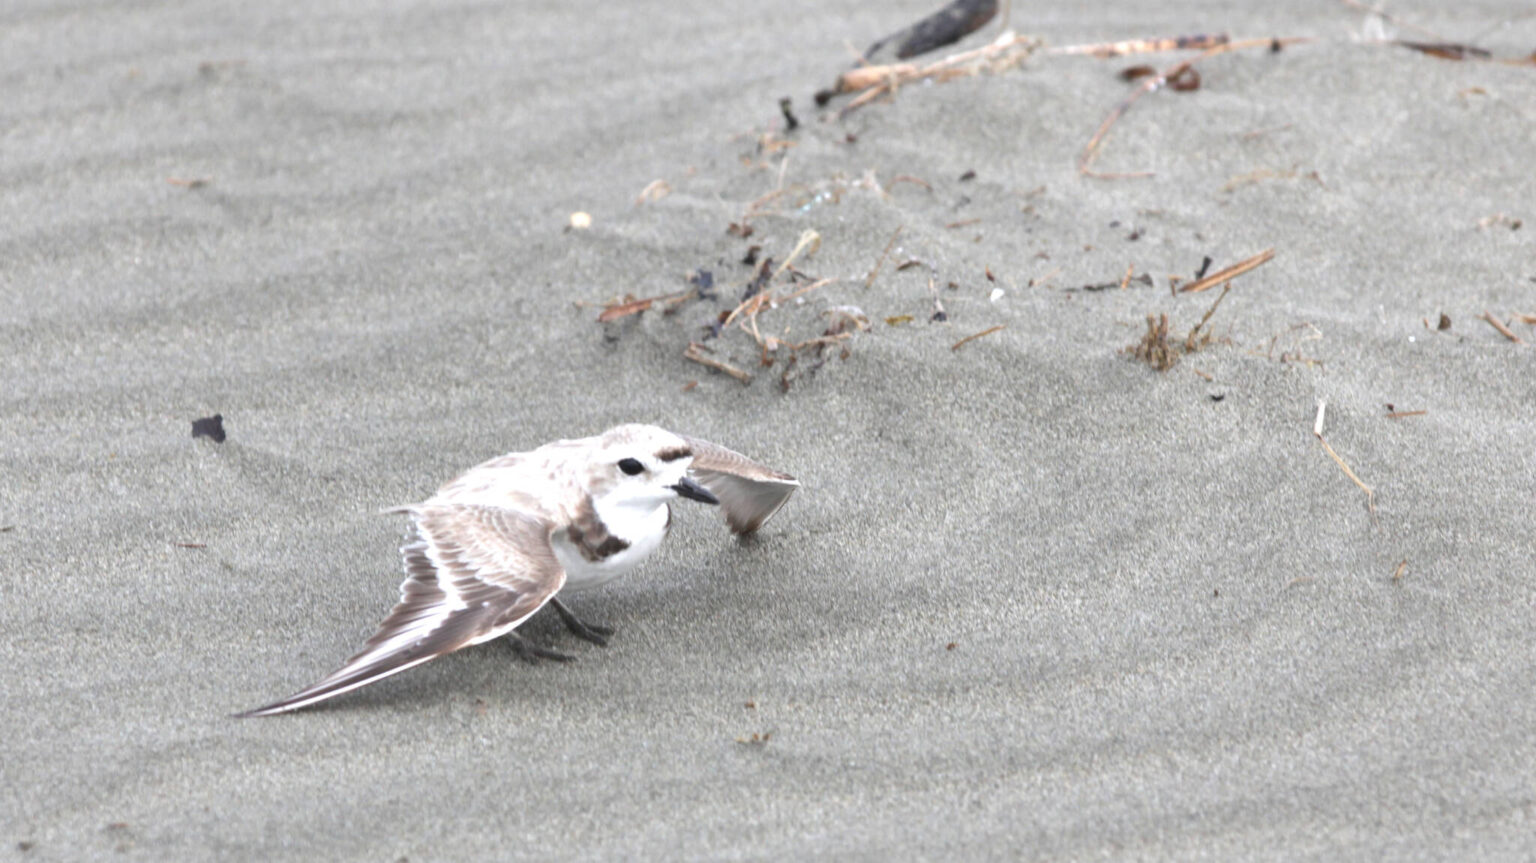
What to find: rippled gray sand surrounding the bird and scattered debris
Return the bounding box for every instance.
[0,0,1536,861]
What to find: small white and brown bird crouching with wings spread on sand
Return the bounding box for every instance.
[235,424,800,719]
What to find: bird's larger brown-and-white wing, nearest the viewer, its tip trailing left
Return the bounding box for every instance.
[238,505,565,717]
